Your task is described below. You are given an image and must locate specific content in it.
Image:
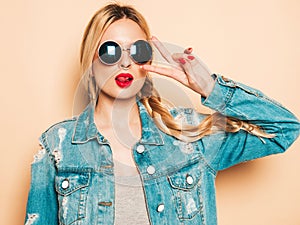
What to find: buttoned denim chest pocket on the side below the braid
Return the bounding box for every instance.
[168,163,204,221]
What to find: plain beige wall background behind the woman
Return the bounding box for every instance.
[0,0,300,225]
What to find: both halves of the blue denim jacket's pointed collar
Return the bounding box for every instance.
[72,101,164,145]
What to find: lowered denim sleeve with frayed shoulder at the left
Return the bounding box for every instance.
[25,137,58,225]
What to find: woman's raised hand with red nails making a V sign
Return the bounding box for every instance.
[141,37,215,97]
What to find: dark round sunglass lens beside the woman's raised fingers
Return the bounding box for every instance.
[130,40,152,64]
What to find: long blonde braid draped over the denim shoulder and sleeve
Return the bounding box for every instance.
[142,96,275,142]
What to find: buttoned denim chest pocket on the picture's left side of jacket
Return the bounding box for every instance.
[55,172,90,225]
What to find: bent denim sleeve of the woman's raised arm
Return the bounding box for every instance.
[202,75,300,170]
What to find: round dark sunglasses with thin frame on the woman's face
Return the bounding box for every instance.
[98,40,152,65]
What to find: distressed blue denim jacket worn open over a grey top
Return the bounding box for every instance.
[25,75,300,225]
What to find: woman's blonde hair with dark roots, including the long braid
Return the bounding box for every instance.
[80,3,273,142]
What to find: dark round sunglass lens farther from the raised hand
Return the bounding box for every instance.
[98,41,122,64]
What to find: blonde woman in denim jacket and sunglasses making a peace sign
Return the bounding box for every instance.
[25,4,300,225]
